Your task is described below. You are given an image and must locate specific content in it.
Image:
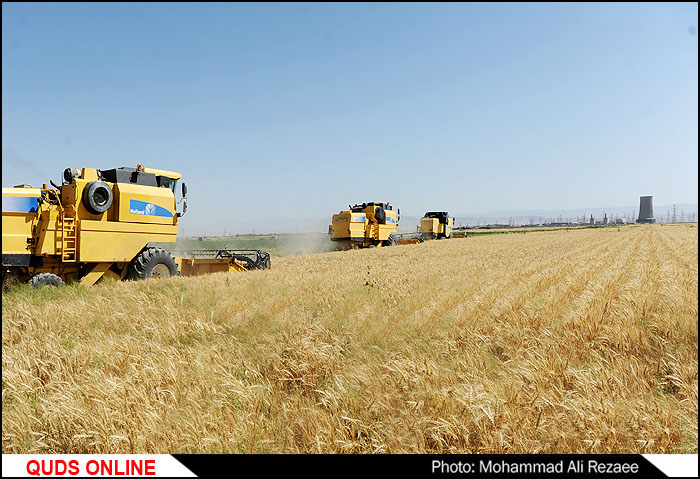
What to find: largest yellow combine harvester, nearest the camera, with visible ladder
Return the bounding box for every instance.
[2,165,270,287]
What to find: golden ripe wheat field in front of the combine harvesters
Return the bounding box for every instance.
[2,224,698,453]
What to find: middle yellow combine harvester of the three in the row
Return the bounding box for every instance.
[328,202,422,250]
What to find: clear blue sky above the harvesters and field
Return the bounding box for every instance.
[2,3,698,234]
